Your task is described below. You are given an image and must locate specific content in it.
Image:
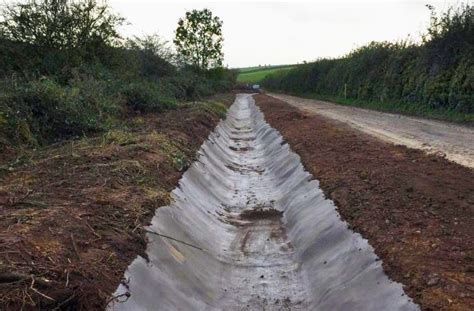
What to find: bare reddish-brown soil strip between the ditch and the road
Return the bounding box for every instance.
[255,94,474,310]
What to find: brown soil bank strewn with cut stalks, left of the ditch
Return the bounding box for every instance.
[0,94,233,310]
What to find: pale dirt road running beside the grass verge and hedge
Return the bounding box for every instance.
[269,94,474,168]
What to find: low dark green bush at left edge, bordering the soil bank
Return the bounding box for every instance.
[0,78,119,144]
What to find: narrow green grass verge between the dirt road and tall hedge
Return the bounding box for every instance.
[293,93,474,126]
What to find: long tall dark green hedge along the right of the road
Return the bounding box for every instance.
[262,5,474,122]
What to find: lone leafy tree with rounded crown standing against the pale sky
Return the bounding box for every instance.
[174,9,224,70]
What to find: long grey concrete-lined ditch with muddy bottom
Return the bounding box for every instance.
[109,94,418,310]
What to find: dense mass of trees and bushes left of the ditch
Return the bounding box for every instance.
[0,0,234,150]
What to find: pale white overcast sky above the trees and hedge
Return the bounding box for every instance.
[17,0,466,67]
